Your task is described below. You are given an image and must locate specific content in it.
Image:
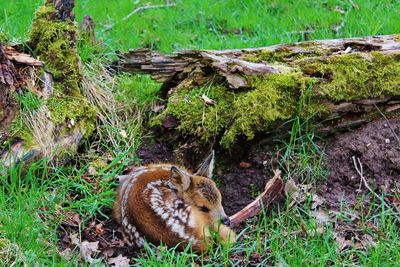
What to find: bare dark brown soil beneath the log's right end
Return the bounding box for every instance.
[318,118,400,208]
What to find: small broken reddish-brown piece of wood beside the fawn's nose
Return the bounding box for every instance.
[229,170,284,227]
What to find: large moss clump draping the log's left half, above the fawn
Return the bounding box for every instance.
[153,73,312,148]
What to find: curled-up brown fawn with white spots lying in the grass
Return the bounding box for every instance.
[114,152,235,252]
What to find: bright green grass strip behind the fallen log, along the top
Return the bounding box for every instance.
[0,0,400,52]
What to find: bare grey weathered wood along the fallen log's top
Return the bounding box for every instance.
[115,35,400,88]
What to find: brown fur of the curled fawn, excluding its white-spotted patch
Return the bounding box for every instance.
[113,161,235,252]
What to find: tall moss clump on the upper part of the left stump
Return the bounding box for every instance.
[30,3,82,95]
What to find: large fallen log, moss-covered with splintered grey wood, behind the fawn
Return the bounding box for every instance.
[114,35,400,148]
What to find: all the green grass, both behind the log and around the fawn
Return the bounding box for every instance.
[0,0,400,266]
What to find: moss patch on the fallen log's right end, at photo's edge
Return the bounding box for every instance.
[301,52,400,101]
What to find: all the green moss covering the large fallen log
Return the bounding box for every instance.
[153,52,400,148]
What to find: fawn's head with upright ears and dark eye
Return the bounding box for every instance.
[170,151,230,226]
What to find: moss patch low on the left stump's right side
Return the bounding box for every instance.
[46,96,96,138]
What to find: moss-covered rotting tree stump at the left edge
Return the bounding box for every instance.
[0,0,96,165]
